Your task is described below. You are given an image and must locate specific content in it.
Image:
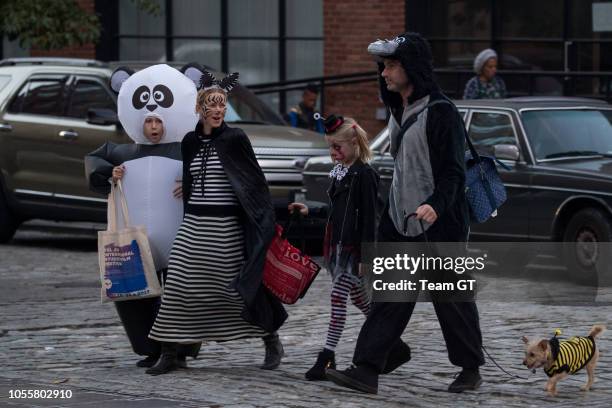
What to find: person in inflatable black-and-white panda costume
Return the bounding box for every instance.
[85,64,201,367]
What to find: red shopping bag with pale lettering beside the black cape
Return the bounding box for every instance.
[263,218,321,305]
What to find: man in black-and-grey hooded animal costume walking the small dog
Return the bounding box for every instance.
[327,33,484,393]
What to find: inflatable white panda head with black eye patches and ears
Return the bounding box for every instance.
[110,64,198,144]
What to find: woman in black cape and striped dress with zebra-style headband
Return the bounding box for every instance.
[147,64,287,375]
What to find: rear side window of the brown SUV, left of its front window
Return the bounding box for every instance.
[9,78,66,116]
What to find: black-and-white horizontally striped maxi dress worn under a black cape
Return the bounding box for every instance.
[149,138,266,343]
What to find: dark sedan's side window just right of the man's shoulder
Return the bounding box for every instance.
[469,112,517,152]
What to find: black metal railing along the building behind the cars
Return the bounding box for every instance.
[248,68,612,114]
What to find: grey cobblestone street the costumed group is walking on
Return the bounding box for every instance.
[0,225,612,407]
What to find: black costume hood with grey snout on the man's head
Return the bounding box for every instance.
[368,32,439,115]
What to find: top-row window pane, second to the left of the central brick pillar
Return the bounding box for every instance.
[228,0,278,37]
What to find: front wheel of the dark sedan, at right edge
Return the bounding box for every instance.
[563,208,612,286]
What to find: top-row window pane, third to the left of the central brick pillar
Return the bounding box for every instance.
[172,0,221,36]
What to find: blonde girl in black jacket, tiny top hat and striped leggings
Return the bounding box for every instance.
[289,115,379,380]
